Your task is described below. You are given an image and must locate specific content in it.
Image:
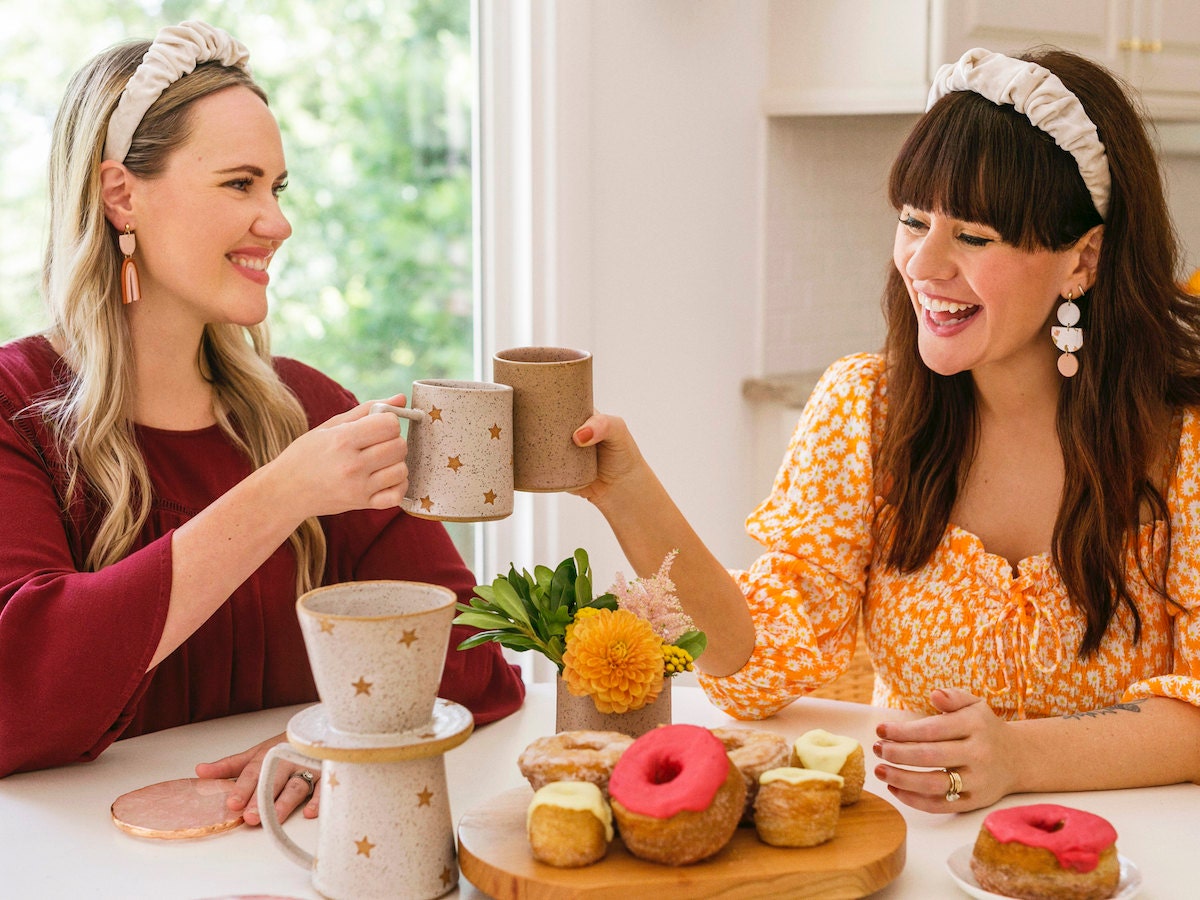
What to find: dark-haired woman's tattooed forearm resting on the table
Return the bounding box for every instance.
[1009,697,1200,793]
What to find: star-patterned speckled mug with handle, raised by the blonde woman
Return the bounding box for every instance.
[371,379,512,522]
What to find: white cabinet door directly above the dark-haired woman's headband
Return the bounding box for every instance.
[929,0,1118,72]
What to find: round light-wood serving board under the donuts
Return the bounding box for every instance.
[458,787,907,900]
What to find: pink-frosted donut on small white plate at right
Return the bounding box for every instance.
[971,803,1121,900]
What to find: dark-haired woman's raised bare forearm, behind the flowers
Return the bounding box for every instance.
[593,464,755,676]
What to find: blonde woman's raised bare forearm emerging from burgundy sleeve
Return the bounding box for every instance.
[158,466,304,668]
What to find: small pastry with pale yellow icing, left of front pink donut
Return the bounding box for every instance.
[526,781,613,868]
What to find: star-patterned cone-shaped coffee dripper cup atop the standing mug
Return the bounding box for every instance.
[296,581,456,734]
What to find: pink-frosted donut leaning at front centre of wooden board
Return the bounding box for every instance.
[608,725,746,865]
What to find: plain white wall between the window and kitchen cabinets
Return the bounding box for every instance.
[500,0,766,588]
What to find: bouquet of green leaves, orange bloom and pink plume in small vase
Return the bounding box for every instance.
[455,548,707,713]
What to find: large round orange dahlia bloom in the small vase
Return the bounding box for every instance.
[563,610,664,713]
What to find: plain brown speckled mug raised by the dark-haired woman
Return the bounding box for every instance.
[492,347,596,492]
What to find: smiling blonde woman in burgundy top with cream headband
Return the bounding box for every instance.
[0,23,523,822]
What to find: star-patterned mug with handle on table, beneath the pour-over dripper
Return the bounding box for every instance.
[258,744,458,900]
